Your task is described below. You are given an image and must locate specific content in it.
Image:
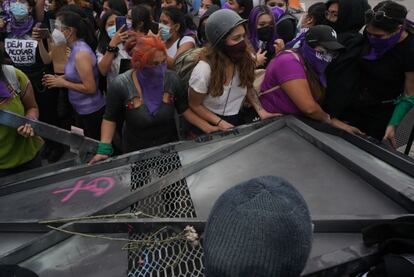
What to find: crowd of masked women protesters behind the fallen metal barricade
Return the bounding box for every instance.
[0,0,414,176]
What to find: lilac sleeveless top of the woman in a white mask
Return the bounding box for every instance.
[65,40,105,115]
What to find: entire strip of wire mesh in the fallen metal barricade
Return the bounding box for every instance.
[128,152,204,277]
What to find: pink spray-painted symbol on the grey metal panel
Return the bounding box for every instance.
[53,177,115,203]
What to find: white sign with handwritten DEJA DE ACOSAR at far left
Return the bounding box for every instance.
[4,38,37,65]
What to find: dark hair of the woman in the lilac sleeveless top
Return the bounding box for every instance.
[56,9,97,51]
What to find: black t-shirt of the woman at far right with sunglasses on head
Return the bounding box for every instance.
[359,34,414,106]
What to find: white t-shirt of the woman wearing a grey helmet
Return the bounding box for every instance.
[189,61,247,116]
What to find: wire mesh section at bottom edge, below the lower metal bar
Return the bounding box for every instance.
[128,226,204,277]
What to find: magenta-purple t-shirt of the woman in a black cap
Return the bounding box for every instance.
[260,52,306,114]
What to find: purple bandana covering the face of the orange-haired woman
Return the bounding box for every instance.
[137,63,167,115]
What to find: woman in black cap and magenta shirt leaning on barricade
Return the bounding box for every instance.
[259,25,362,134]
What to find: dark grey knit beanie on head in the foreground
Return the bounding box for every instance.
[203,176,312,277]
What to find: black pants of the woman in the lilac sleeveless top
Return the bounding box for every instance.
[75,107,105,140]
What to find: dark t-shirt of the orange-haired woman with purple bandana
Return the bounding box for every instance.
[104,70,188,152]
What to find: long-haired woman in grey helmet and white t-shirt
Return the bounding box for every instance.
[189,9,276,134]
